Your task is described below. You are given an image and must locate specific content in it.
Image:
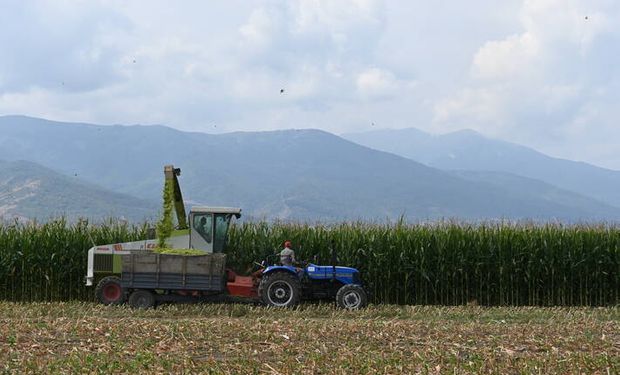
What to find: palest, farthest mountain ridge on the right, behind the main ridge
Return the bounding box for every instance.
[343,128,620,207]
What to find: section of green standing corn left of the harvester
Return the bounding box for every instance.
[0,219,146,301]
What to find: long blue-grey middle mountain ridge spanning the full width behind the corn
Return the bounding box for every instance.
[0,117,618,220]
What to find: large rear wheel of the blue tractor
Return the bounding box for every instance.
[258,272,301,307]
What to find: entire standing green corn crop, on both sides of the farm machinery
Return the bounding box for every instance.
[0,220,620,306]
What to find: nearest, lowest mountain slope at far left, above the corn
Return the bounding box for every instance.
[0,161,158,221]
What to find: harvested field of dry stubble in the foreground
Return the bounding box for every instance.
[0,302,620,374]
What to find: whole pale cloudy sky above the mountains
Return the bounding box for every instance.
[0,0,620,170]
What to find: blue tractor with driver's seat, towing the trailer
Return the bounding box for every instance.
[258,260,368,310]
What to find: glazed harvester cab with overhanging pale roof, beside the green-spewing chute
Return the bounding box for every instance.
[189,207,241,253]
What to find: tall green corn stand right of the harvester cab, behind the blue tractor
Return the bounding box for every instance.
[228,223,620,306]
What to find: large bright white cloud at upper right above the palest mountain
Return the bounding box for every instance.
[434,0,620,167]
